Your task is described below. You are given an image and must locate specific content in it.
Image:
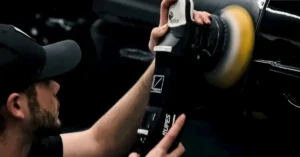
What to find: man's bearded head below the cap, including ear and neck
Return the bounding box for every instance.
[0,80,60,135]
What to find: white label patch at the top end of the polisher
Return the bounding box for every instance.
[168,0,186,27]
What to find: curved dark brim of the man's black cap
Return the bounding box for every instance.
[39,40,81,80]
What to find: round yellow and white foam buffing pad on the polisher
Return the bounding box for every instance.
[204,5,255,88]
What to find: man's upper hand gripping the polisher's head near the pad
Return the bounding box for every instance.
[148,0,211,52]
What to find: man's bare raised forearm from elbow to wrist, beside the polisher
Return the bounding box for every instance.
[92,61,155,156]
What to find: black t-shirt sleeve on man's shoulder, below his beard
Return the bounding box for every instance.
[28,136,63,157]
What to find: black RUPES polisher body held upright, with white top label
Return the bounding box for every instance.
[133,0,195,156]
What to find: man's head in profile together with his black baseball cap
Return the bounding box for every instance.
[0,24,81,137]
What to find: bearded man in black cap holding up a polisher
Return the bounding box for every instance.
[0,0,210,157]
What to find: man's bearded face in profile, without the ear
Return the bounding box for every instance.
[25,80,61,134]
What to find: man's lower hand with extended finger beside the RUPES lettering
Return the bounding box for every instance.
[129,115,185,157]
